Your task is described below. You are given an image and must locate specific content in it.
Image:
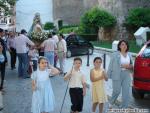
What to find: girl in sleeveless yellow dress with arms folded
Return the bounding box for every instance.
[90,57,108,113]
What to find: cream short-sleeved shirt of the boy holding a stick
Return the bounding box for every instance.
[68,69,86,88]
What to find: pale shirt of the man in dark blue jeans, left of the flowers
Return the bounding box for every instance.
[15,34,34,53]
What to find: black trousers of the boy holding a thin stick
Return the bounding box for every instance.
[69,88,83,112]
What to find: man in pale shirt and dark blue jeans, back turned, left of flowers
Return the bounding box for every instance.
[15,29,34,78]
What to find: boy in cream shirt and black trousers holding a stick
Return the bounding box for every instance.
[64,57,86,113]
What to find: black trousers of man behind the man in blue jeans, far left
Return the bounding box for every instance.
[10,48,16,69]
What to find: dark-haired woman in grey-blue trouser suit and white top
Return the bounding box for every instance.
[107,40,133,108]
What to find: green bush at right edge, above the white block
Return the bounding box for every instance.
[125,8,150,30]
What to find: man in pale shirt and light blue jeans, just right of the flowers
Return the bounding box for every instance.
[41,34,57,66]
